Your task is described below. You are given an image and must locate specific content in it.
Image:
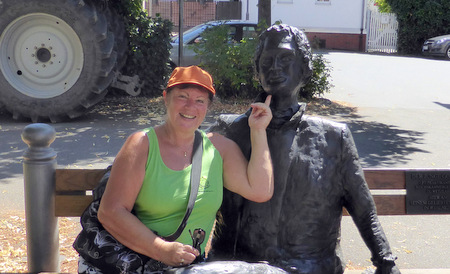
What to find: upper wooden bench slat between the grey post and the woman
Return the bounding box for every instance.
[55,169,106,192]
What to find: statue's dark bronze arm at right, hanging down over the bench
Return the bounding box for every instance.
[341,127,400,273]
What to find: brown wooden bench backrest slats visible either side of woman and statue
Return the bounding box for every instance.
[55,169,450,217]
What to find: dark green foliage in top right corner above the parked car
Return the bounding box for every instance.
[387,0,450,54]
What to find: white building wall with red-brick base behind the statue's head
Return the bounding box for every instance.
[241,0,366,51]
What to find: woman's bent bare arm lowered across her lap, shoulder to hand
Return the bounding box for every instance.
[98,132,199,266]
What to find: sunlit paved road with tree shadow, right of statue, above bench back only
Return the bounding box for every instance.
[325,52,450,168]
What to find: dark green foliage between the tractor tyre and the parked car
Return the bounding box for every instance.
[110,0,173,96]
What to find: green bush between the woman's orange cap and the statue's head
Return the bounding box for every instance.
[193,25,260,98]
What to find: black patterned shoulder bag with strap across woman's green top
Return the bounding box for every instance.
[73,130,203,273]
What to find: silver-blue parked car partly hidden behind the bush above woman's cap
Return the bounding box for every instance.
[170,20,258,67]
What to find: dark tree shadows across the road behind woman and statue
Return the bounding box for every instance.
[0,96,427,184]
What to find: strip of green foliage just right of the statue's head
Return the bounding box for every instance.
[299,54,333,99]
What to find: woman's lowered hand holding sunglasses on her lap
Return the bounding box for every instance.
[159,241,200,266]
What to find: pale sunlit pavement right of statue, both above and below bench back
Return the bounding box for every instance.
[318,52,450,273]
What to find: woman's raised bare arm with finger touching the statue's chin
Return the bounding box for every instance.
[210,96,273,202]
